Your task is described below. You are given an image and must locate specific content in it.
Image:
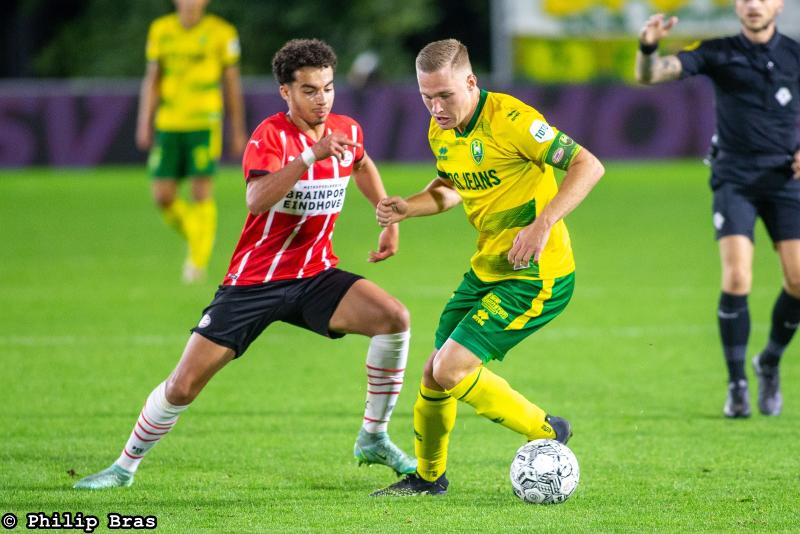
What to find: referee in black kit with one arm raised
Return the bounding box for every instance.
[636,0,800,417]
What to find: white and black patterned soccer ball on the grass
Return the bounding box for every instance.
[511,439,580,504]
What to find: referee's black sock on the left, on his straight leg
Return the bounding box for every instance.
[717,291,750,382]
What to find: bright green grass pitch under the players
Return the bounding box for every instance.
[0,161,800,532]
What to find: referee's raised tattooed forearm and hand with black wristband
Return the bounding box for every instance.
[636,13,682,84]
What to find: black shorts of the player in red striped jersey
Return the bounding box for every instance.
[191,268,362,358]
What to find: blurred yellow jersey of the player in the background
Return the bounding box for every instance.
[146,13,239,132]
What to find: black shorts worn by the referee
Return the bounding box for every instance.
[712,179,800,243]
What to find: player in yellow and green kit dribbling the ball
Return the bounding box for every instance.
[373,39,604,496]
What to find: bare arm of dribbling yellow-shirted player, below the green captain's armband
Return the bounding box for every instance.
[508,148,605,269]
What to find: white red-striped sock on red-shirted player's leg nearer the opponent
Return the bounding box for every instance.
[364,330,411,434]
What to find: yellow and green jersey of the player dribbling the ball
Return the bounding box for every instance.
[428,91,581,282]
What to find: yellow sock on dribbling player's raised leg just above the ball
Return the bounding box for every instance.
[447,366,556,440]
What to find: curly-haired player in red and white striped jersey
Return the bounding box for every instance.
[75,39,416,489]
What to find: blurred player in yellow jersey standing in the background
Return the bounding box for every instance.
[136,0,247,283]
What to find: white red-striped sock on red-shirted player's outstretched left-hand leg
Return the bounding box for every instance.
[114,382,189,473]
